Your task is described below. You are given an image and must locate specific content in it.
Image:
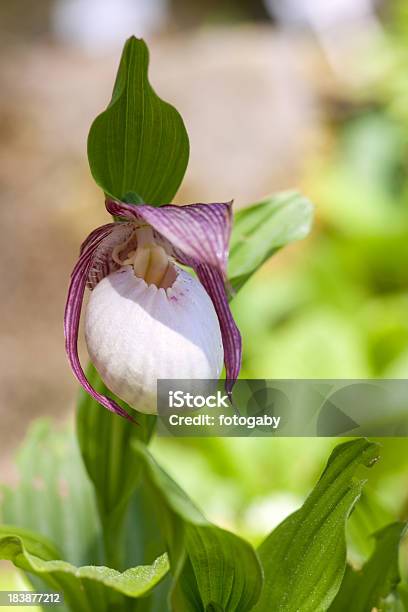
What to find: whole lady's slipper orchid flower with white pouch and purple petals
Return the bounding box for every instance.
[64,200,241,420]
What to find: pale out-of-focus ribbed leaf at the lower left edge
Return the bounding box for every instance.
[0,420,102,565]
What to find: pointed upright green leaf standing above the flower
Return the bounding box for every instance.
[88,36,189,205]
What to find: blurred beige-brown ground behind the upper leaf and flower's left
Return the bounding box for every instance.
[0,26,319,481]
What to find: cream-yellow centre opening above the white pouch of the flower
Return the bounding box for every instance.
[112,225,177,290]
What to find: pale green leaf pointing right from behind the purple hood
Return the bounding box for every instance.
[228,192,313,291]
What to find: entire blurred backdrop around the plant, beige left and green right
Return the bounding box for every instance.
[0,0,408,588]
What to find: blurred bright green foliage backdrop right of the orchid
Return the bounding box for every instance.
[153,2,408,538]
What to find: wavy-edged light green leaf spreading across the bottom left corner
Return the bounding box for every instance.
[0,525,169,612]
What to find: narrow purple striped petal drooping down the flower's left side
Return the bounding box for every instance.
[64,223,135,423]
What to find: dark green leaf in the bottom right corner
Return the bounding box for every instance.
[330,523,406,612]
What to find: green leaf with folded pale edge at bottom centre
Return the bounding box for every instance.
[133,443,262,612]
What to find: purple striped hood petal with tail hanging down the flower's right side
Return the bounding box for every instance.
[106,200,242,384]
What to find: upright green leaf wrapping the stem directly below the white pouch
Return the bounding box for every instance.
[77,364,156,568]
